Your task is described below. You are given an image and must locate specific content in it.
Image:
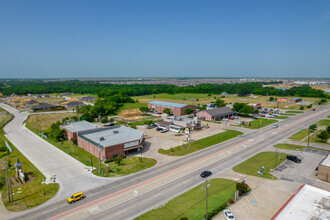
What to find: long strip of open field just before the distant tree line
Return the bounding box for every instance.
[132,93,319,109]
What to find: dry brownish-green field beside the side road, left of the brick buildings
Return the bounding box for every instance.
[26,112,81,131]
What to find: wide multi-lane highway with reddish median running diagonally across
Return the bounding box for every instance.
[1,103,329,219]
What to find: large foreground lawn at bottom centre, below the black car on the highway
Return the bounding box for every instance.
[136,179,236,220]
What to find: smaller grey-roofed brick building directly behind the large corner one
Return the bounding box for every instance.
[60,121,99,140]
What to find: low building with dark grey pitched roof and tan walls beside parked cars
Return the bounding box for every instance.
[196,107,237,121]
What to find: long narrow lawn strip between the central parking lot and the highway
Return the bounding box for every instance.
[158,130,243,156]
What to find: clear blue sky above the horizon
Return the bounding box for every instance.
[0,0,330,78]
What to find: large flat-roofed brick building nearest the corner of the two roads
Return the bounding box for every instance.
[77,125,144,160]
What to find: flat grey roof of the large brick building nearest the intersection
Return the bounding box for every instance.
[78,125,144,147]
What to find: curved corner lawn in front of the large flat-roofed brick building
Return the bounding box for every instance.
[93,157,157,177]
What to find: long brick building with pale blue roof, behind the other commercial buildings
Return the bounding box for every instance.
[148,101,196,115]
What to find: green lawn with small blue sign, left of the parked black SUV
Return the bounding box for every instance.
[233,152,286,179]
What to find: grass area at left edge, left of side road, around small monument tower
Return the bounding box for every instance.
[0,108,59,211]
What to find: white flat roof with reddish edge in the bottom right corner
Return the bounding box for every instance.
[272,184,330,220]
